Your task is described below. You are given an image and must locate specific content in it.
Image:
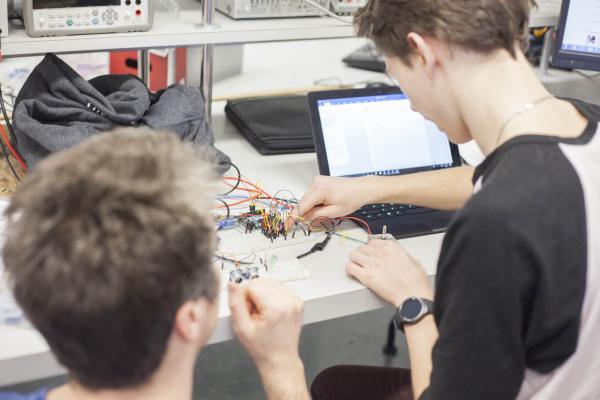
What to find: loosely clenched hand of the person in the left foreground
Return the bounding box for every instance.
[228,278,303,370]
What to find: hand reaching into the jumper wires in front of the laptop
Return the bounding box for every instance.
[292,175,371,222]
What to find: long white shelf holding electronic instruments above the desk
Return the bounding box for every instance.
[2,0,560,57]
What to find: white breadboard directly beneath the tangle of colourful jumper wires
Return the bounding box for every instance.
[217,229,315,256]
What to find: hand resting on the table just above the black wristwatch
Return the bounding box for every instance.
[346,240,433,307]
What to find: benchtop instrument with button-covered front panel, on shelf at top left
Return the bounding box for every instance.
[23,0,154,37]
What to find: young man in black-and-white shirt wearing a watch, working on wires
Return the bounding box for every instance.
[298,0,600,400]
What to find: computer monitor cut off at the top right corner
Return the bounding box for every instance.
[552,0,600,71]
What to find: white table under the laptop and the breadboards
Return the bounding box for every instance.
[0,98,442,386]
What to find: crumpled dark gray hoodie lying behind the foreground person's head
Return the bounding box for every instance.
[13,54,230,173]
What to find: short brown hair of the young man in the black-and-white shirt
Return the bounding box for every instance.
[354,0,536,65]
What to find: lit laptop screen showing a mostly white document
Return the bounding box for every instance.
[316,93,454,177]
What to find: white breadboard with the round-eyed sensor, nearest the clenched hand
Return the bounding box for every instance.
[217,257,311,290]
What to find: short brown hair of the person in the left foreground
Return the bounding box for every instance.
[3,128,218,389]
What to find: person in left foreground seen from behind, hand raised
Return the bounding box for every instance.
[0,128,308,400]
